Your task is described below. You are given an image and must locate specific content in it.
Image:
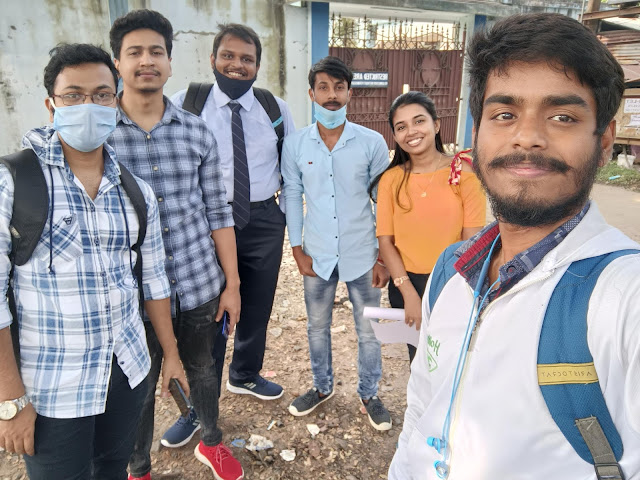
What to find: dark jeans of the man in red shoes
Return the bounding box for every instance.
[129,297,222,477]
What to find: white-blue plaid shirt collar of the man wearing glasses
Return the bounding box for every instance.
[22,125,120,185]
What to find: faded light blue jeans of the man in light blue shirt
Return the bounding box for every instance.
[304,267,382,400]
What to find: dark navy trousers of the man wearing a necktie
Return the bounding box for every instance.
[214,200,286,384]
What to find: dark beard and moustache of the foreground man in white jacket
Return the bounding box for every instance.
[473,142,602,227]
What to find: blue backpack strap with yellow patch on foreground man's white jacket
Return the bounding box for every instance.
[538,250,640,479]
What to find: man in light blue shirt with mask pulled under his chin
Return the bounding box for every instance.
[282,57,391,430]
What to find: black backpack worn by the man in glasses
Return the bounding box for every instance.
[0,149,147,358]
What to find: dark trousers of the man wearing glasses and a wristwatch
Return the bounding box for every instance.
[24,357,147,480]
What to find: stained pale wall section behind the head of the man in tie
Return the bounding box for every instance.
[144,0,309,127]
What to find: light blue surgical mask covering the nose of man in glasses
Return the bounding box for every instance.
[51,100,116,152]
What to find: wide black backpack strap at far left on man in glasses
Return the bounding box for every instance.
[0,149,49,265]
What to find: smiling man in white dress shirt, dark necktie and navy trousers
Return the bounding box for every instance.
[162,24,295,446]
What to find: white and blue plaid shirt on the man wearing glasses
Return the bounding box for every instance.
[0,127,170,418]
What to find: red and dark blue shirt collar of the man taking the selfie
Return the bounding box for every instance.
[454,202,591,301]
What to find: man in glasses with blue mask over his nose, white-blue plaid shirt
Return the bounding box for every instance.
[0,44,188,480]
